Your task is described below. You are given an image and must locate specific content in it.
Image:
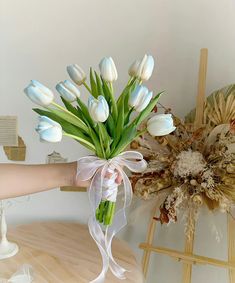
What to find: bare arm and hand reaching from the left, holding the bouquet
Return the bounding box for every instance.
[0,162,121,199]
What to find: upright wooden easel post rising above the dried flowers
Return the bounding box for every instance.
[194,48,208,129]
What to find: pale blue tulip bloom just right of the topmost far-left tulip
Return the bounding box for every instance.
[56,80,80,102]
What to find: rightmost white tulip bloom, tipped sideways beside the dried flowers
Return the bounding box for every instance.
[147,114,176,136]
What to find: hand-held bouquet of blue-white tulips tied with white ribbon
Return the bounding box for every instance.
[25,55,175,282]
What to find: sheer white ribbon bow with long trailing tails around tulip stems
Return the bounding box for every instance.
[77,151,147,283]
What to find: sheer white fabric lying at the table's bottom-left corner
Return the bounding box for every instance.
[0,264,33,283]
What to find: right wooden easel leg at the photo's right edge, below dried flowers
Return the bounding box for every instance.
[228,214,235,283]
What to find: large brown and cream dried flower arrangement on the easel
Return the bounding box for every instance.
[131,85,235,237]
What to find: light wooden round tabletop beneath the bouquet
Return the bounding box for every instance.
[0,222,143,283]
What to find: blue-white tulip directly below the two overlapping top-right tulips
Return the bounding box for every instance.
[129,85,153,112]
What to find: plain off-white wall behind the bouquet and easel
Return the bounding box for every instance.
[0,0,235,283]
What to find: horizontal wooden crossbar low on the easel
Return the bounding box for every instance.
[139,243,235,272]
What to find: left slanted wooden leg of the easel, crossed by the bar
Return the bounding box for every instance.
[142,207,157,278]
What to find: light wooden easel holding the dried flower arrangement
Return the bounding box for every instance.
[139,48,235,283]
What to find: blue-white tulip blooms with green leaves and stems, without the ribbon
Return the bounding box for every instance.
[25,55,174,225]
